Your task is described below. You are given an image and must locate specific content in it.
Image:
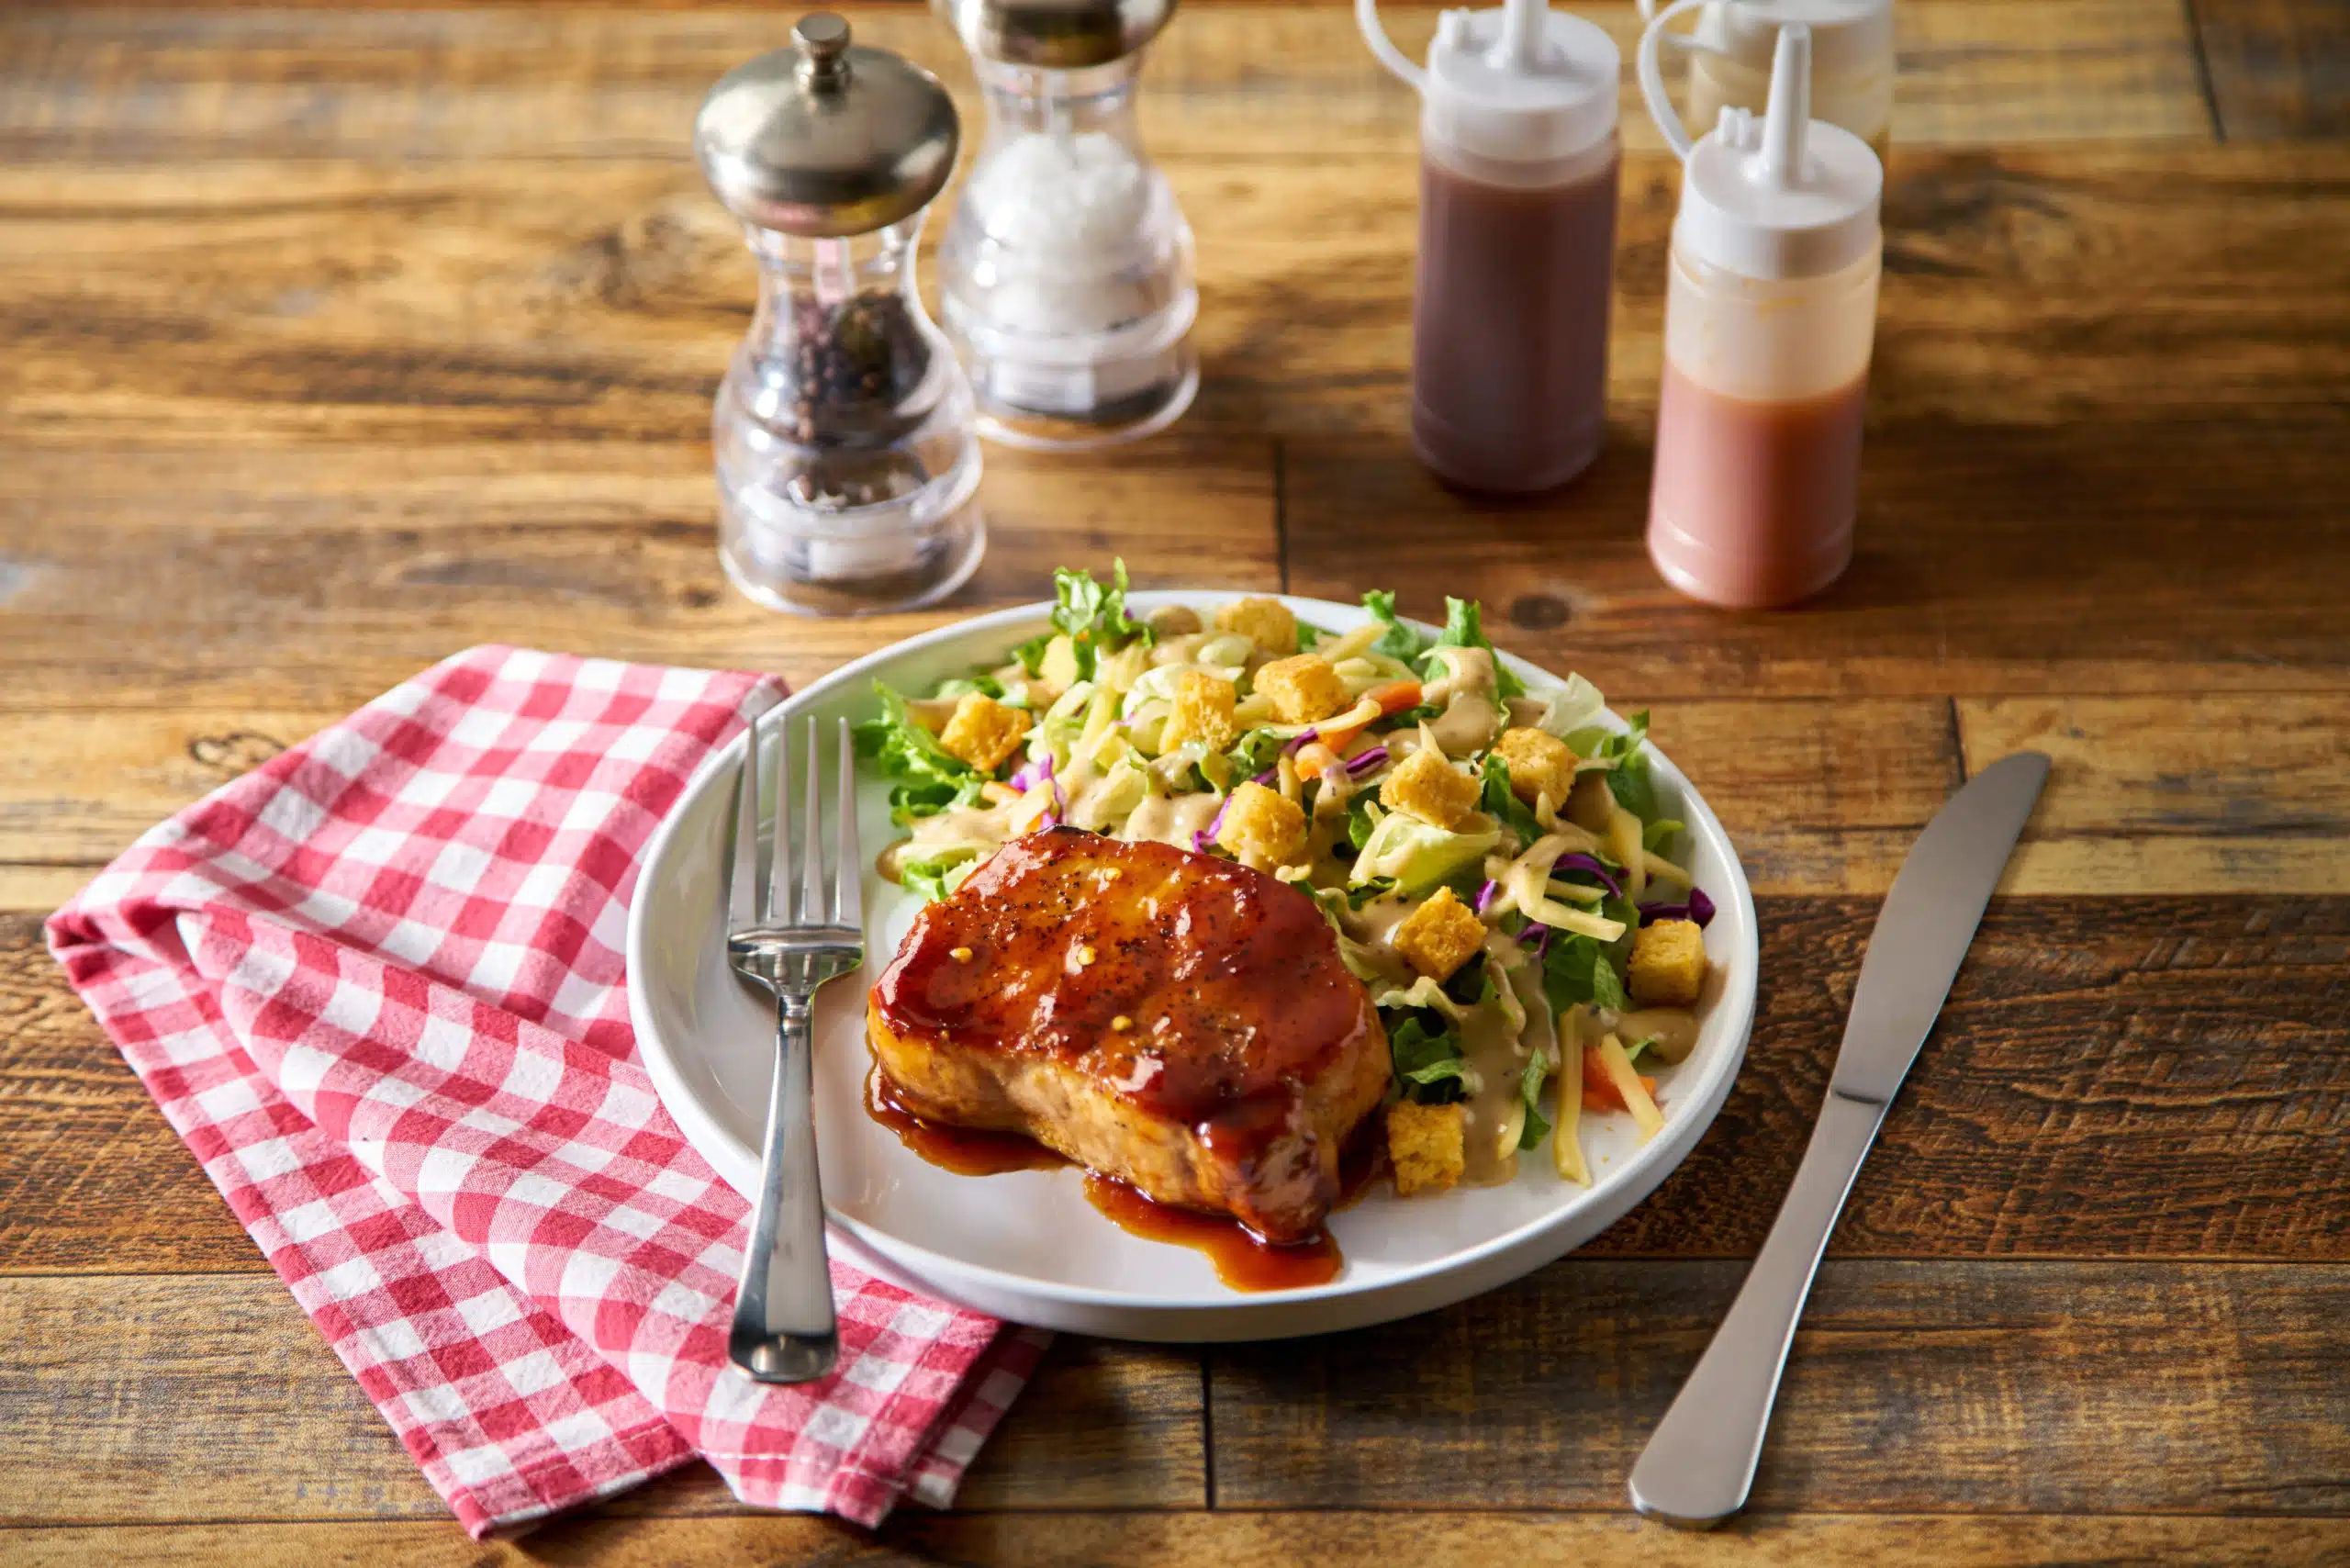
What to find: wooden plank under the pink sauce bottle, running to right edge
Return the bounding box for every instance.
[1283,416,2350,710]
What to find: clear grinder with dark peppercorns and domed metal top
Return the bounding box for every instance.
[693,12,987,616]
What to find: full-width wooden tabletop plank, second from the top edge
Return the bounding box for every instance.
[0,143,2350,454]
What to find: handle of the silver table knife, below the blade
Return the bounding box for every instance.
[1631,1089,1885,1530]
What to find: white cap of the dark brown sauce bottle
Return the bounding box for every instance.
[1356,0,1624,162]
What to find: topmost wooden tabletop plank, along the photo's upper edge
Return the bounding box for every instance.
[0,0,2209,166]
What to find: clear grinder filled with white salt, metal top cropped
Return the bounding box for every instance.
[935,0,1199,452]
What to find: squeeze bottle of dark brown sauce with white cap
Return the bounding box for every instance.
[1354,0,1621,491]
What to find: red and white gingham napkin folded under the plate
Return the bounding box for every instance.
[50,646,1044,1538]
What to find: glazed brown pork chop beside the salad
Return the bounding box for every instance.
[867,827,1389,1241]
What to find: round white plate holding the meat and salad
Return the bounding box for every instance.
[628,592,1755,1340]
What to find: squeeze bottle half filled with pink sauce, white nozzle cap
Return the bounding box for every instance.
[1640,14,1885,609]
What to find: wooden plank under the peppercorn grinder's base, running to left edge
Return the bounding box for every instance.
[0,434,1281,719]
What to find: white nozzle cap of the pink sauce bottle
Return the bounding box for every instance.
[1640,17,1885,280]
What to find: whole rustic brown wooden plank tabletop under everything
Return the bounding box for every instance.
[0,0,2350,1568]
